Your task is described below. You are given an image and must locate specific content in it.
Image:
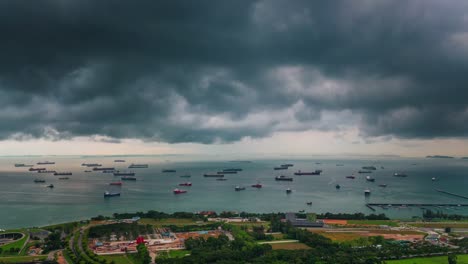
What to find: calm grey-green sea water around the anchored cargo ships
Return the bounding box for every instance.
[0,157,468,229]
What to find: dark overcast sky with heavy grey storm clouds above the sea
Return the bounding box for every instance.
[0,0,468,156]
